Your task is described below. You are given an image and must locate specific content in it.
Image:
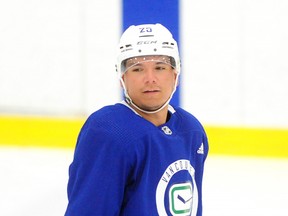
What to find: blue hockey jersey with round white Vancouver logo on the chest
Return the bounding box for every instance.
[65,103,208,216]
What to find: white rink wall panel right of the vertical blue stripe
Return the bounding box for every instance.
[182,0,288,128]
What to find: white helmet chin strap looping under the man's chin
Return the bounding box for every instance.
[120,74,179,114]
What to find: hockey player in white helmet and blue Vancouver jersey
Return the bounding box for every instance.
[65,24,208,216]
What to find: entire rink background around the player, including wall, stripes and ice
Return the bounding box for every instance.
[0,0,288,216]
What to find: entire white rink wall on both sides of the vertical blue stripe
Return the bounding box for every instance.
[0,0,288,128]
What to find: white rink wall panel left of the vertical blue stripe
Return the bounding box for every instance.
[0,0,121,116]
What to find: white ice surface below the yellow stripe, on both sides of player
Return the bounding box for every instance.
[0,147,288,216]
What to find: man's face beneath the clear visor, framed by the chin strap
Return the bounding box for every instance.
[123,56,177,111]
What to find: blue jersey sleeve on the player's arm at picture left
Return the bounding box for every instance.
[65,120,131,216]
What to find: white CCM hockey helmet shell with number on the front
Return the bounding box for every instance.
[116,23,180,77]
